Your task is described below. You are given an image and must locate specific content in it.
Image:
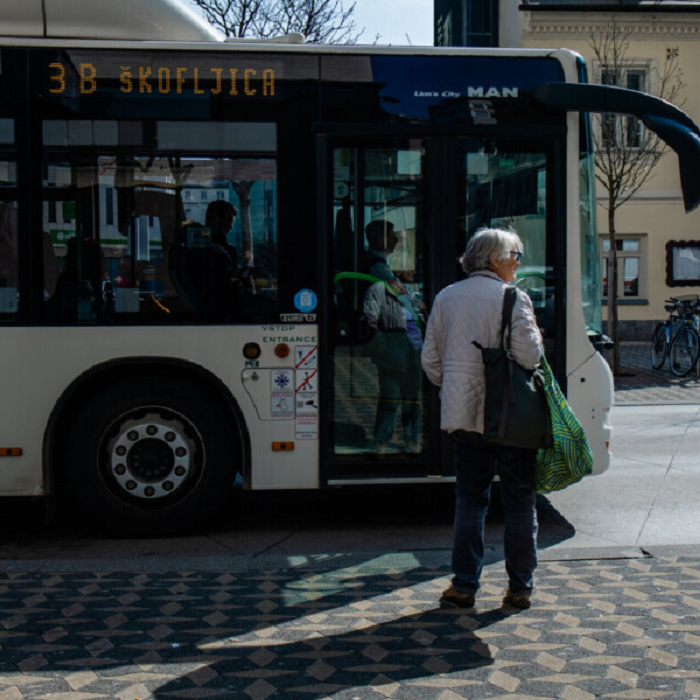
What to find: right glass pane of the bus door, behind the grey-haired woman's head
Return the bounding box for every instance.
[456,139,563,364]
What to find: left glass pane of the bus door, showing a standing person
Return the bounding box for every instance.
[328,140,428,481]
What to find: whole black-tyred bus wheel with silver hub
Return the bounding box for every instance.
[66,377,239,536]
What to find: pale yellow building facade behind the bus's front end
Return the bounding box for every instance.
[516,3,700,340]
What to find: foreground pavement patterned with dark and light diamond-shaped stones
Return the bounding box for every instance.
[0,556,700,700]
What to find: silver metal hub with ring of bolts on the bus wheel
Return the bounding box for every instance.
[107,411,201,500]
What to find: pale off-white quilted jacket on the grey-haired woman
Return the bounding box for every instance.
[422,271,543,433]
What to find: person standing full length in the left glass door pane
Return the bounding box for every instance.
[363,220,423,459]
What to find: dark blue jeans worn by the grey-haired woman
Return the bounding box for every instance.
[452,430,537,595]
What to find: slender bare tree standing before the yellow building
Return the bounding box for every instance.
[588,15,685,376]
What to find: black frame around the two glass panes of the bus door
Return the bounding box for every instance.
[315,125,578,487]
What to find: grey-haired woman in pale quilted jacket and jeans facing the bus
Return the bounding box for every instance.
[422,229,543,608]
